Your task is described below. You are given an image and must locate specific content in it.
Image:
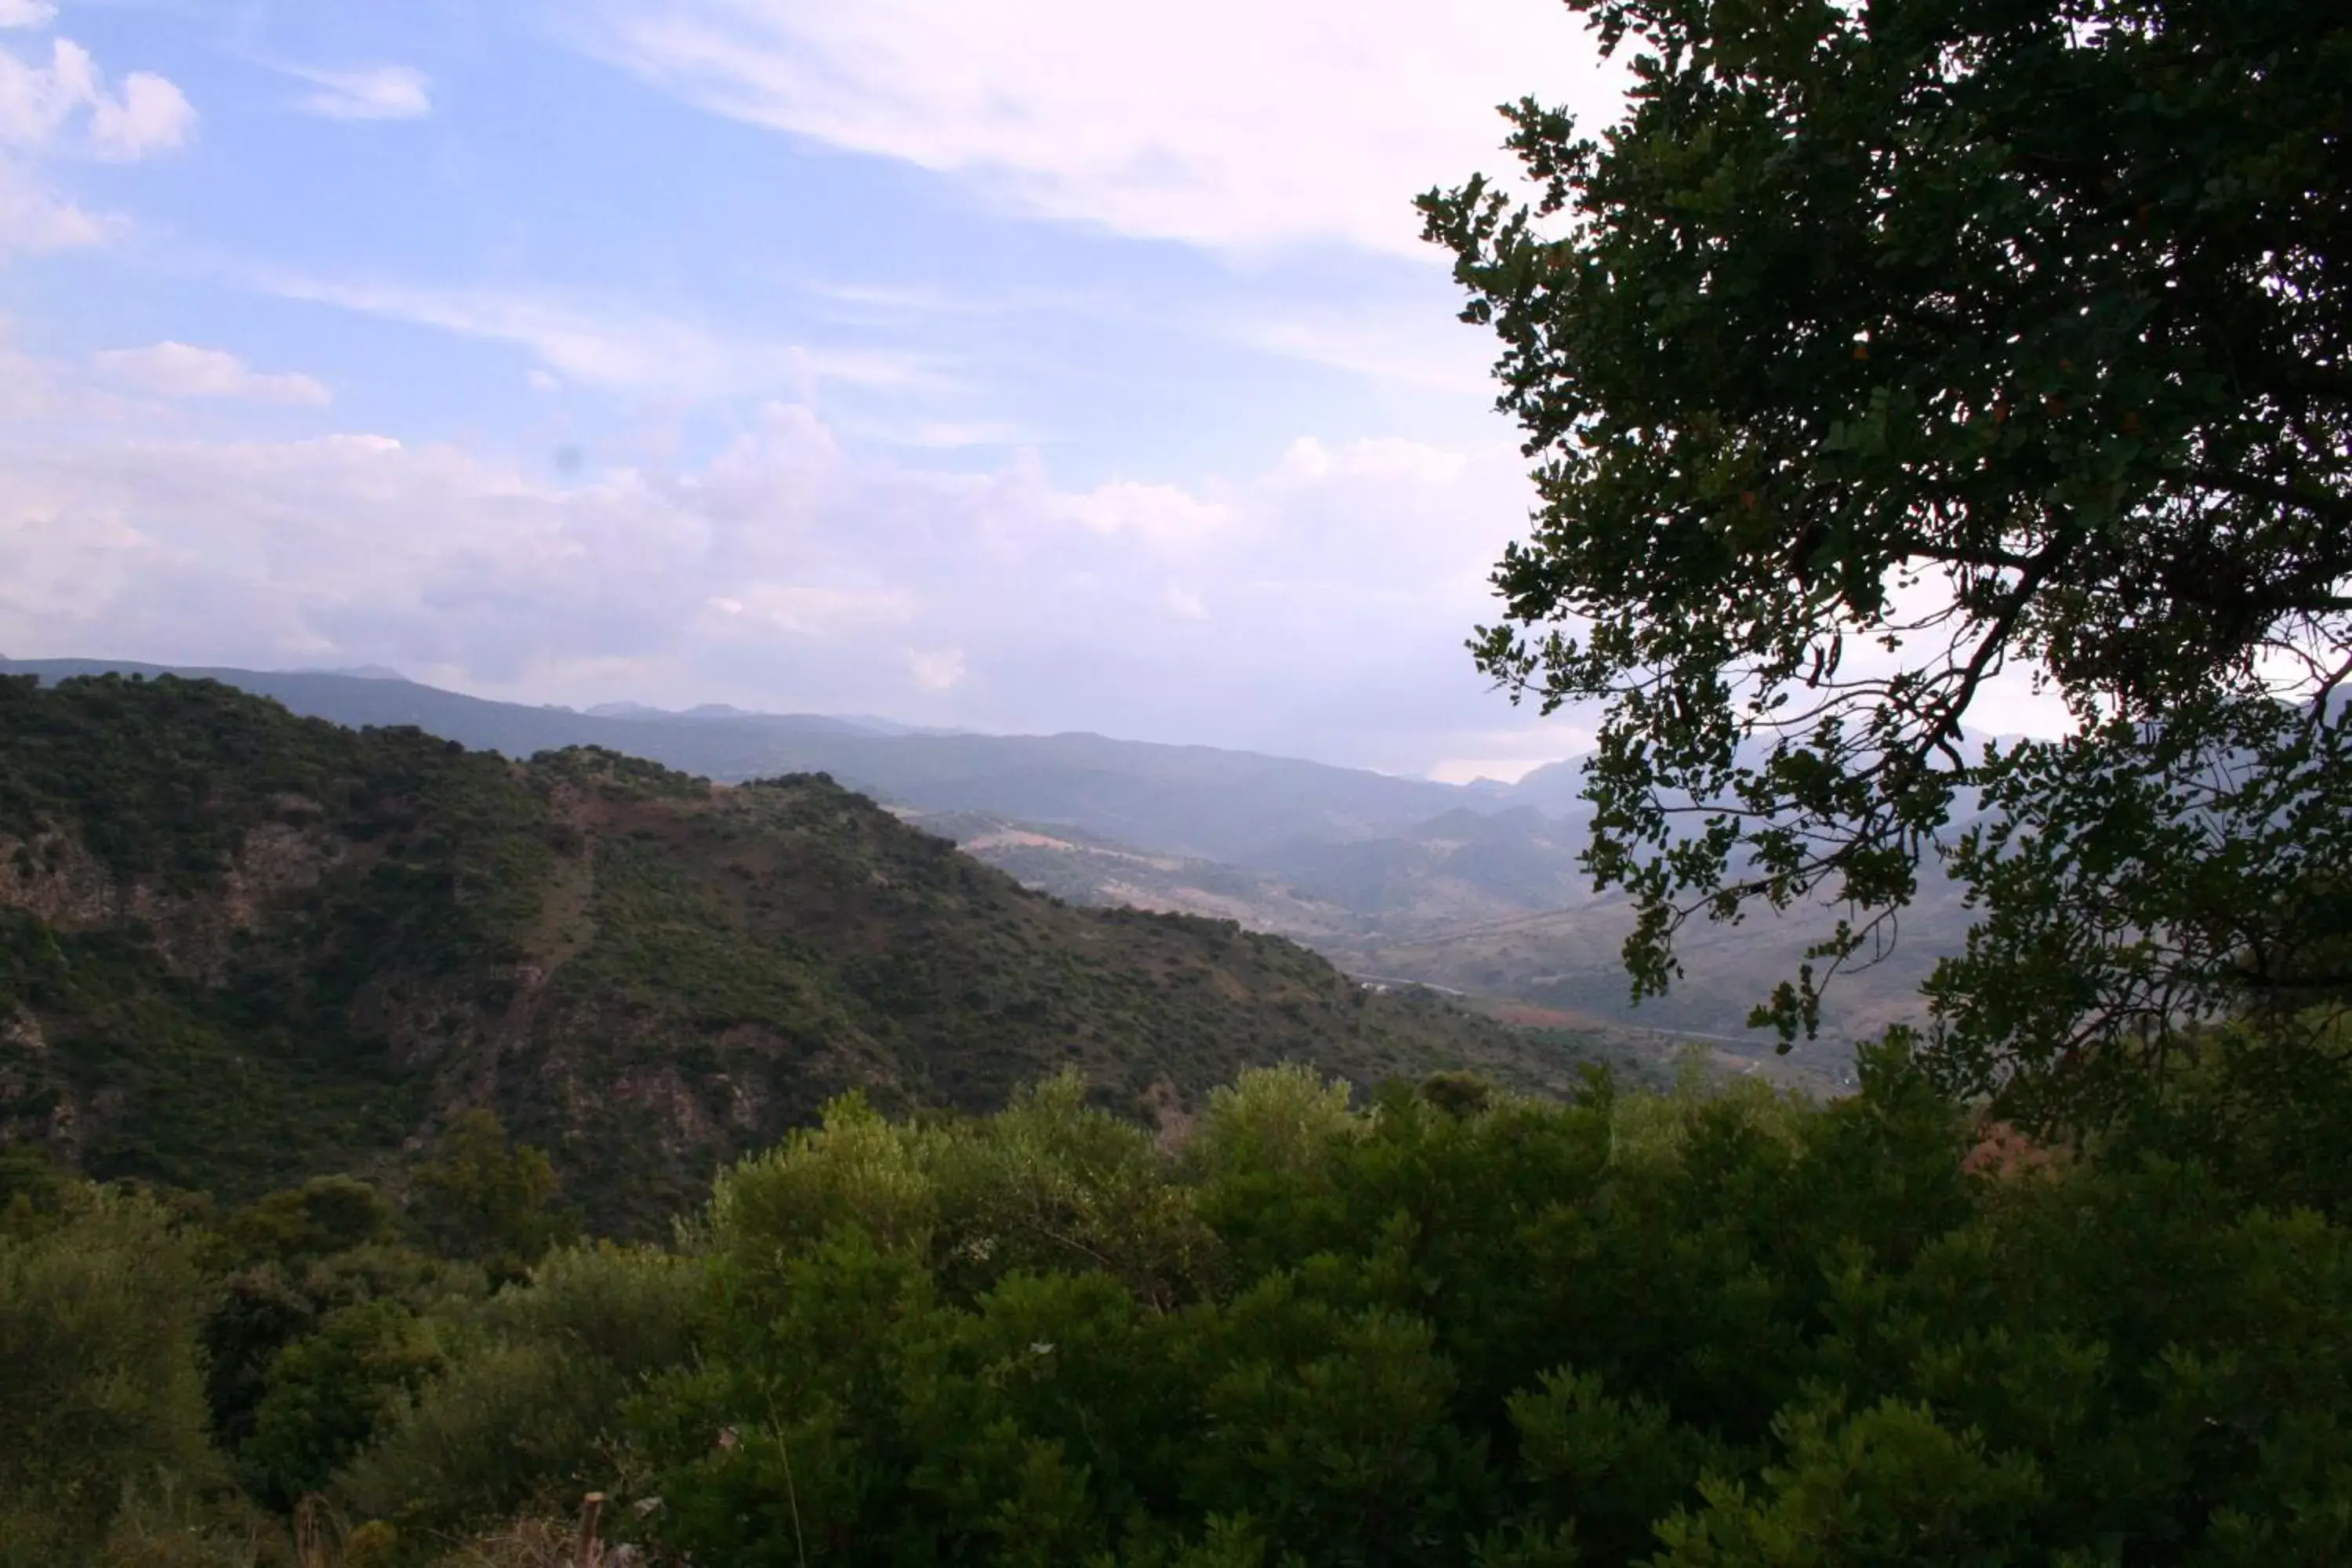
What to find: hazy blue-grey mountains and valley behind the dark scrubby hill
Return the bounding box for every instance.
[0,661,1969,1072]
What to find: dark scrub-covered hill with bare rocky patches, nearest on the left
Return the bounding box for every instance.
[0,677,1569,1229]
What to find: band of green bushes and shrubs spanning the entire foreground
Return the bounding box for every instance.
[0,1034,2352,1568]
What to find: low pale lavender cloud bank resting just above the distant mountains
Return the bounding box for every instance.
[0,392,1569,771]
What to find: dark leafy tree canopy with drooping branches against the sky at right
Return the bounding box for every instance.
[1423,0,2352,1114]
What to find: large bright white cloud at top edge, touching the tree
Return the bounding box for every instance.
[574,0,1616,254]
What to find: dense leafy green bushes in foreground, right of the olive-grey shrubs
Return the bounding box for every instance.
[579,1046,2352,1568]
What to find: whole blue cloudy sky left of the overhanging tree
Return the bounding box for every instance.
[0,0,1618,779]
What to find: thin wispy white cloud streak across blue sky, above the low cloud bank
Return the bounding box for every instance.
[254,275,938,400]
